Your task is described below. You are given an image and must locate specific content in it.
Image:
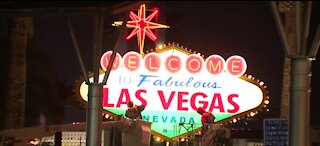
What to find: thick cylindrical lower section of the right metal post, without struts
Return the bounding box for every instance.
[289,57,311,146]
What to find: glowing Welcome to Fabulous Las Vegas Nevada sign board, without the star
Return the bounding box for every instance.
[80,44,269,140]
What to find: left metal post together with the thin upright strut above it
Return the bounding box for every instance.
[86,11,103,146]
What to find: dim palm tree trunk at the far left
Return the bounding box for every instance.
[5,17,33,128]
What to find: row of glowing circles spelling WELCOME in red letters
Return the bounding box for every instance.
[100,51,247,77]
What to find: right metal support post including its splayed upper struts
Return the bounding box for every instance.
[270,1,320,146]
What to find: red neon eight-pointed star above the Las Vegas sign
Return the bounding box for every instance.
[127,4,169,54]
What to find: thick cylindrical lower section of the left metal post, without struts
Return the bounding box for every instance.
[86,83,102,146]
